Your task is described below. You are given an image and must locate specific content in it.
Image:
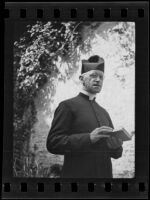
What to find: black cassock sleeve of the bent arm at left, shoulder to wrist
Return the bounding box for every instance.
[46,102,92,155]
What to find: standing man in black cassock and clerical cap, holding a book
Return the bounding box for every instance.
[47,55,123,178]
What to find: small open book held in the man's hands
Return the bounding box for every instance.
[104,128,133,141]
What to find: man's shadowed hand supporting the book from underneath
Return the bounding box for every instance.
[107,137,123,149]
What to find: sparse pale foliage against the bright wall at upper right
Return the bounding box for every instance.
[107,22,135,84]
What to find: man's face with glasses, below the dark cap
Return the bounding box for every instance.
[81,70,104,94]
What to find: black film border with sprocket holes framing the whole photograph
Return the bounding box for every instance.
[2,2,149,199]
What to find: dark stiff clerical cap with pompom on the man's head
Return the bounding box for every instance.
[81,55,104,74]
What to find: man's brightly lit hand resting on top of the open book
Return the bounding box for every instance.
[90,126,113,143]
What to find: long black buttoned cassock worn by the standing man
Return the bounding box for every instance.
[46,93,123,178]
